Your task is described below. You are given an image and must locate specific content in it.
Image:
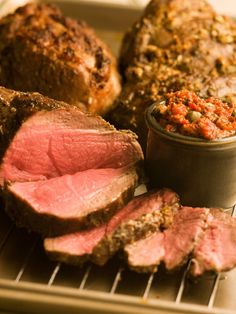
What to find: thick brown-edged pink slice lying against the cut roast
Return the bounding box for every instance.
[5,168,138,236]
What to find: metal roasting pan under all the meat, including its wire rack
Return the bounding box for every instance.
[0,0,236,314]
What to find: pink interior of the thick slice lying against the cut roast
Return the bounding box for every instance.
[9,168,129,218]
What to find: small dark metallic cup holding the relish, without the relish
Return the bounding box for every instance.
[146,104,236,208]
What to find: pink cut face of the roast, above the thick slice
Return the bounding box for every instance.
[0,105,143,182]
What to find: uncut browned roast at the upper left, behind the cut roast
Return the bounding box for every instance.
[0,3,120,114]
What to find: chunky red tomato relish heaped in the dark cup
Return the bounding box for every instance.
[152,90,236,140]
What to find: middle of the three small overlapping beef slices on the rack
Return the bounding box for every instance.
[125,207,209,272]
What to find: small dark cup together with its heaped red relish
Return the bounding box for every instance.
[145,91,236,208]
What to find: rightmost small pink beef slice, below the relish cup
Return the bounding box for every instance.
[191,209,236,276]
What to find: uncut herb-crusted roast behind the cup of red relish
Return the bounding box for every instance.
[108,0,236,149]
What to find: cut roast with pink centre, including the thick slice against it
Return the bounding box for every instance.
[0,88,143,235]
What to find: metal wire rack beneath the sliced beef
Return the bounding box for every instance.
[0,207,236,313]
